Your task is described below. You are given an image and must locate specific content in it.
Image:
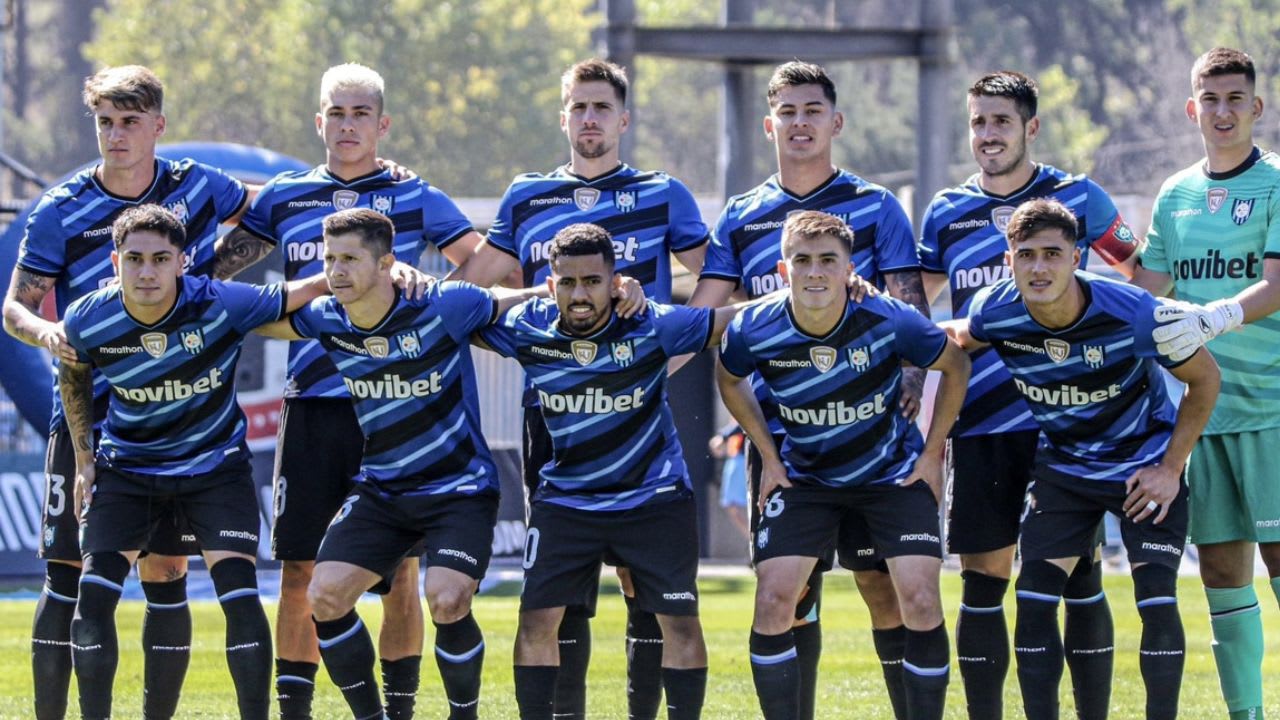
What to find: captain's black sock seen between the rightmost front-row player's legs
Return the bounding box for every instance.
[1062,560,1115,720]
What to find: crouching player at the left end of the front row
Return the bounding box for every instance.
[59,205,324,720]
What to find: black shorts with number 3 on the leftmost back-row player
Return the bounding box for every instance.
[38,424,200,562]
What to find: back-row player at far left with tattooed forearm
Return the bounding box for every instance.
[4,65,247,720]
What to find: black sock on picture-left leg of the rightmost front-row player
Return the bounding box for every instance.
[1014,560,1066,720]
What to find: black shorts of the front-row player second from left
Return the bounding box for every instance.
[316,483,498,582]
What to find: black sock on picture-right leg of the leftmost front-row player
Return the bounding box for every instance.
[209,557,271,720]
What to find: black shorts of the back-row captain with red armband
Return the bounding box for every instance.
[947,430,1039,555]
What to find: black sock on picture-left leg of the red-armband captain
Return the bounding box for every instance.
[956,570,1009,720]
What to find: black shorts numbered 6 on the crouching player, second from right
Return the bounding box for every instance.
[755,482,942,562]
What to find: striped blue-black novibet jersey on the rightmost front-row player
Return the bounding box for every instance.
[969,270,1179,483]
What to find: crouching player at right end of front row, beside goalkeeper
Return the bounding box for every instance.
[956,199,1219,720]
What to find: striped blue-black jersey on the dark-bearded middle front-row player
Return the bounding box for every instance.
[480,299,712,510]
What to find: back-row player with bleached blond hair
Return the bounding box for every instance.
[215,64,480,720]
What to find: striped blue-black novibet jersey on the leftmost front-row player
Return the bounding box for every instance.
[64,277,284,475]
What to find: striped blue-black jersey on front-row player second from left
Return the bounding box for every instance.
[289,282,499,495]
